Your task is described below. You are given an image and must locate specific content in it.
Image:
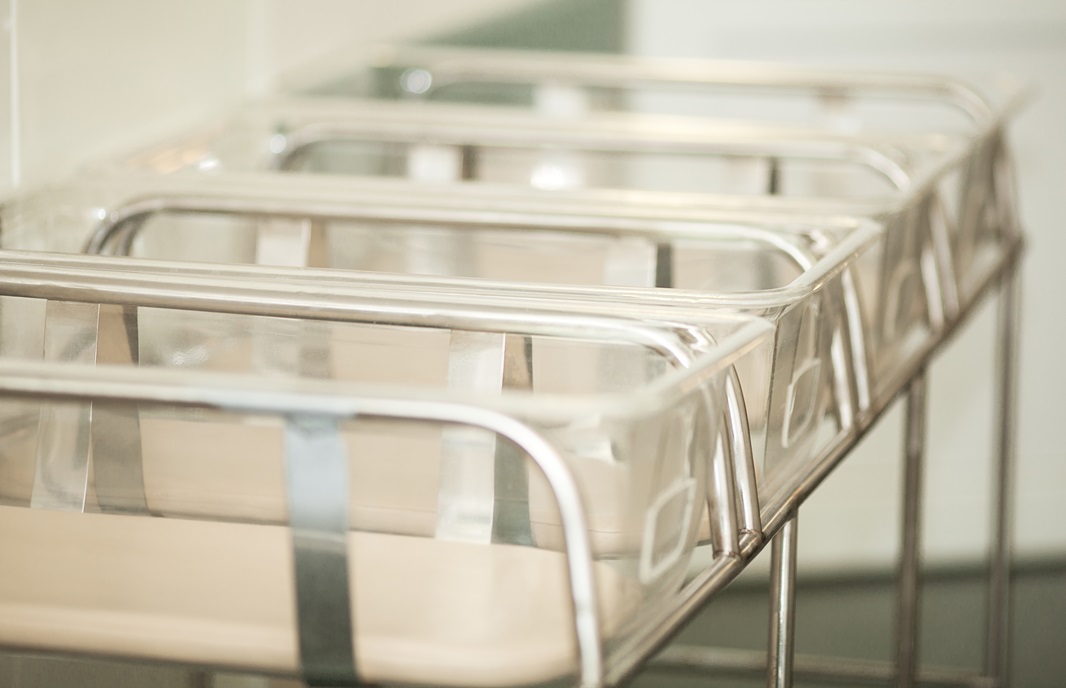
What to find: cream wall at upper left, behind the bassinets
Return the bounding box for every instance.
[0,0,530,188]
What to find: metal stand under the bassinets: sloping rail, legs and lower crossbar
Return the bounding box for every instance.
[648,238,1023,688]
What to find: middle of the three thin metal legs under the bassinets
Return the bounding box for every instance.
[895,370,926,688]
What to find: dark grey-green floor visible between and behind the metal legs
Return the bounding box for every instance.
[634,562,1066,688]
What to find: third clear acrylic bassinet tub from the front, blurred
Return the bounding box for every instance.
[103,94,1002,319]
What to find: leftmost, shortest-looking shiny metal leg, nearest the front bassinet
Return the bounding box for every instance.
[766,513,796,688]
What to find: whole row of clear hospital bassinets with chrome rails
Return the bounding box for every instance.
[0,50,1021,686]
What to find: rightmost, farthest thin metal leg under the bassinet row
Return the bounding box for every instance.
[985,270,1021,687]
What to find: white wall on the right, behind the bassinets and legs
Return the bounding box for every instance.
[629,0,1066,567]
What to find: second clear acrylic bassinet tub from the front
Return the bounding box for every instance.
[0,174,882,516]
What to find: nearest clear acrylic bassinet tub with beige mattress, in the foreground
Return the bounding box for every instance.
[0,253,770,685]
